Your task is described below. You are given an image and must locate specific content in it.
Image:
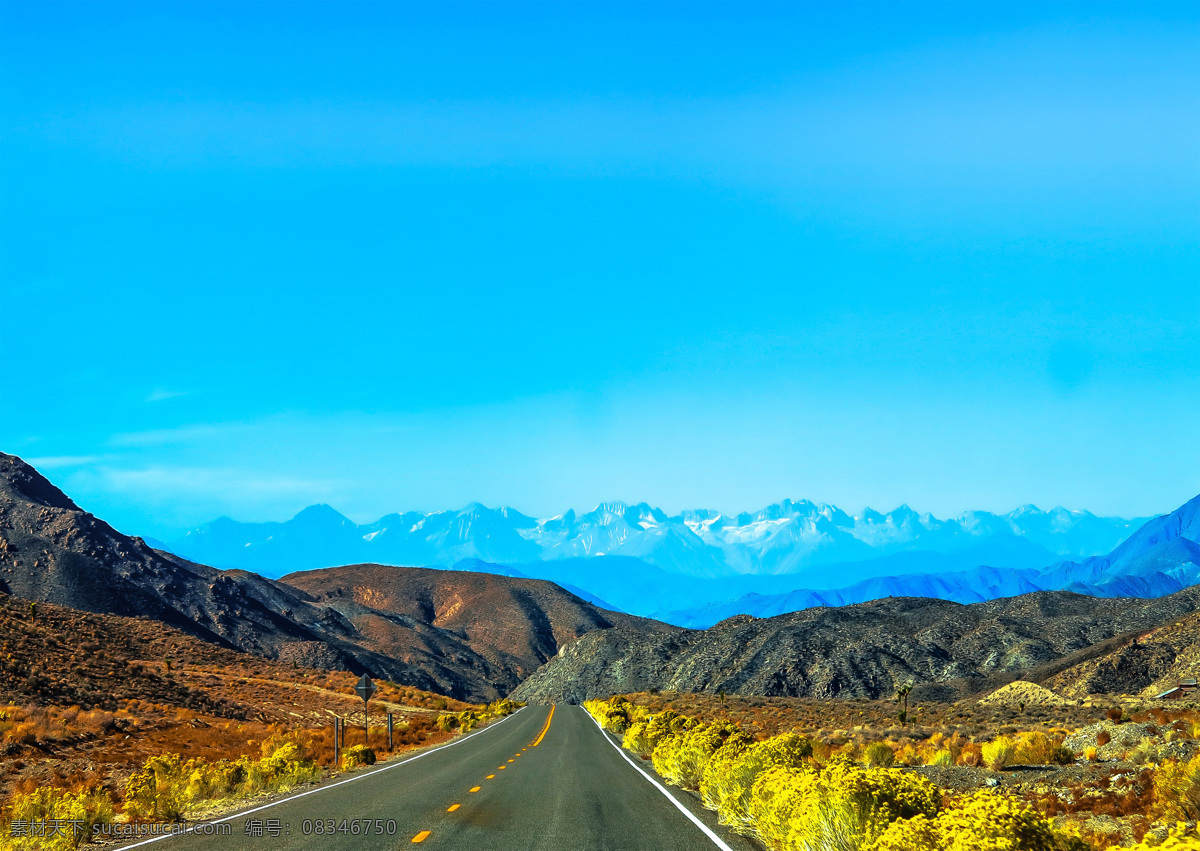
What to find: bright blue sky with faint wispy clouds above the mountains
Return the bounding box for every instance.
[0,2,1200,535]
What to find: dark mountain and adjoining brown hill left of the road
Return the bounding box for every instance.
[0,454,638,700]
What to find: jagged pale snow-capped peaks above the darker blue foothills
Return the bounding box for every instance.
[166,499,1144,587]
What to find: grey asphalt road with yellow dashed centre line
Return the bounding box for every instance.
[110,706,754,851]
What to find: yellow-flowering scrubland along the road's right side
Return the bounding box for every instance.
[584,693,1200,851]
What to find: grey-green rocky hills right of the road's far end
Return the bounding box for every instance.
[514,588,1200,702]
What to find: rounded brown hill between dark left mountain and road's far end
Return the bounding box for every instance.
[280,564,648,694]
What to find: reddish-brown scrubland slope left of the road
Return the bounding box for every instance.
[0,595,520,851]
